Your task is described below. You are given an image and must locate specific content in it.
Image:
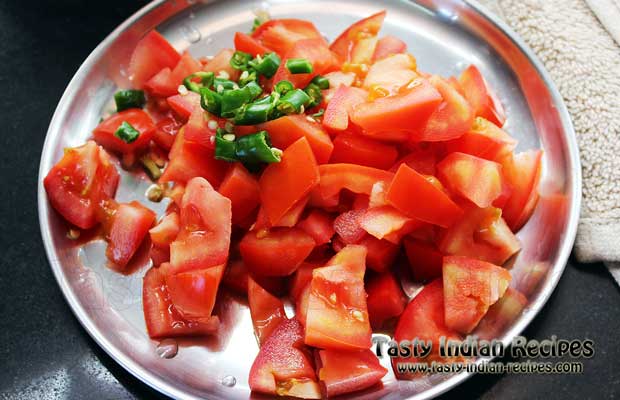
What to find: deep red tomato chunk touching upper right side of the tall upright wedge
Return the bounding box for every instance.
[218,163,260,224]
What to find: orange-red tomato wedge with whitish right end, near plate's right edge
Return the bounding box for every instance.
[446,117,517,161]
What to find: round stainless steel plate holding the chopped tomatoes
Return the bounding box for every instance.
[39,0,581,399]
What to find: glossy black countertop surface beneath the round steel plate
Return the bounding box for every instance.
[0,0,620,400]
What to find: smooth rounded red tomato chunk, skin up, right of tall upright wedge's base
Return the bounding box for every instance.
[239,228,314,276]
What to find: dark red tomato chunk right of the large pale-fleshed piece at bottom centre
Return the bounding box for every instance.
[366,272,407,329]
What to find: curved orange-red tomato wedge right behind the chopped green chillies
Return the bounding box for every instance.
[252,18,326,56]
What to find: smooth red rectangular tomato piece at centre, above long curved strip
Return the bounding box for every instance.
[330,132,398,169]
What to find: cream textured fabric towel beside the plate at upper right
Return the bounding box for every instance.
[479,0,620,283]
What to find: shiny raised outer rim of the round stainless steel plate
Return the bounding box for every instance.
[38,0,582,399]
